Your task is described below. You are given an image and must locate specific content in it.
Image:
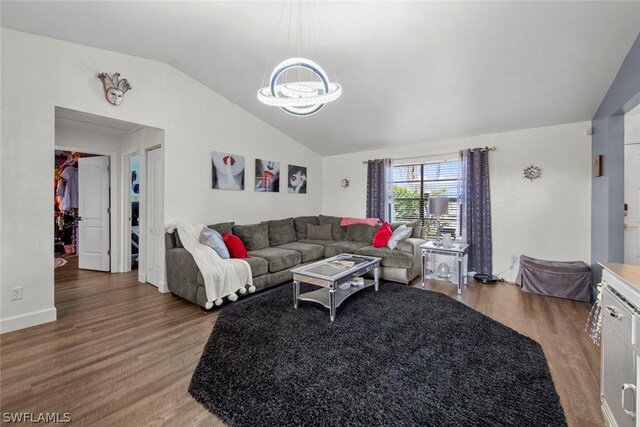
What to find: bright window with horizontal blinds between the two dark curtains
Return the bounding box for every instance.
[393,160,460,237]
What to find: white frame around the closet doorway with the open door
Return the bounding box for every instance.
[52,145,122,273]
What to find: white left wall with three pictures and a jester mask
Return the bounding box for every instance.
[0,28,322,332]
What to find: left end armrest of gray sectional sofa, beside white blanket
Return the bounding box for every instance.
[165,248,200,304]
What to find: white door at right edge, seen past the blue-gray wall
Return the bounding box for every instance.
[624,144,640,265]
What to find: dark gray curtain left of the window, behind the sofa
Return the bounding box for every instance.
[367,159,393,221]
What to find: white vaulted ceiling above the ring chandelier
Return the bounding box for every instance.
[1,1,640,155]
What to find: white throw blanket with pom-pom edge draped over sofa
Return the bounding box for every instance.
[167,222,254,308]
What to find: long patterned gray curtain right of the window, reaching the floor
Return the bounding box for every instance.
[460,148,493,274]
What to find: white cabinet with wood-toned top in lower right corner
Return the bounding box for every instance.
[600,264,640,427]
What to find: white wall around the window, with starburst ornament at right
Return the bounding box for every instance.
[323,122,591,280]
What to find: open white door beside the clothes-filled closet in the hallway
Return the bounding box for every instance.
[78,156,110,271]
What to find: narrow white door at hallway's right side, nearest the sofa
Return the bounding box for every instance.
[145,148,164,287]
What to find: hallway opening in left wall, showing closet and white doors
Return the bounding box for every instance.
[54,107,166,292]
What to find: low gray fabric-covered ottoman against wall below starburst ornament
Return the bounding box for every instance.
[516,255,591,302]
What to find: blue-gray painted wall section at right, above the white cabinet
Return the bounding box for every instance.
[591,34,640,284]
